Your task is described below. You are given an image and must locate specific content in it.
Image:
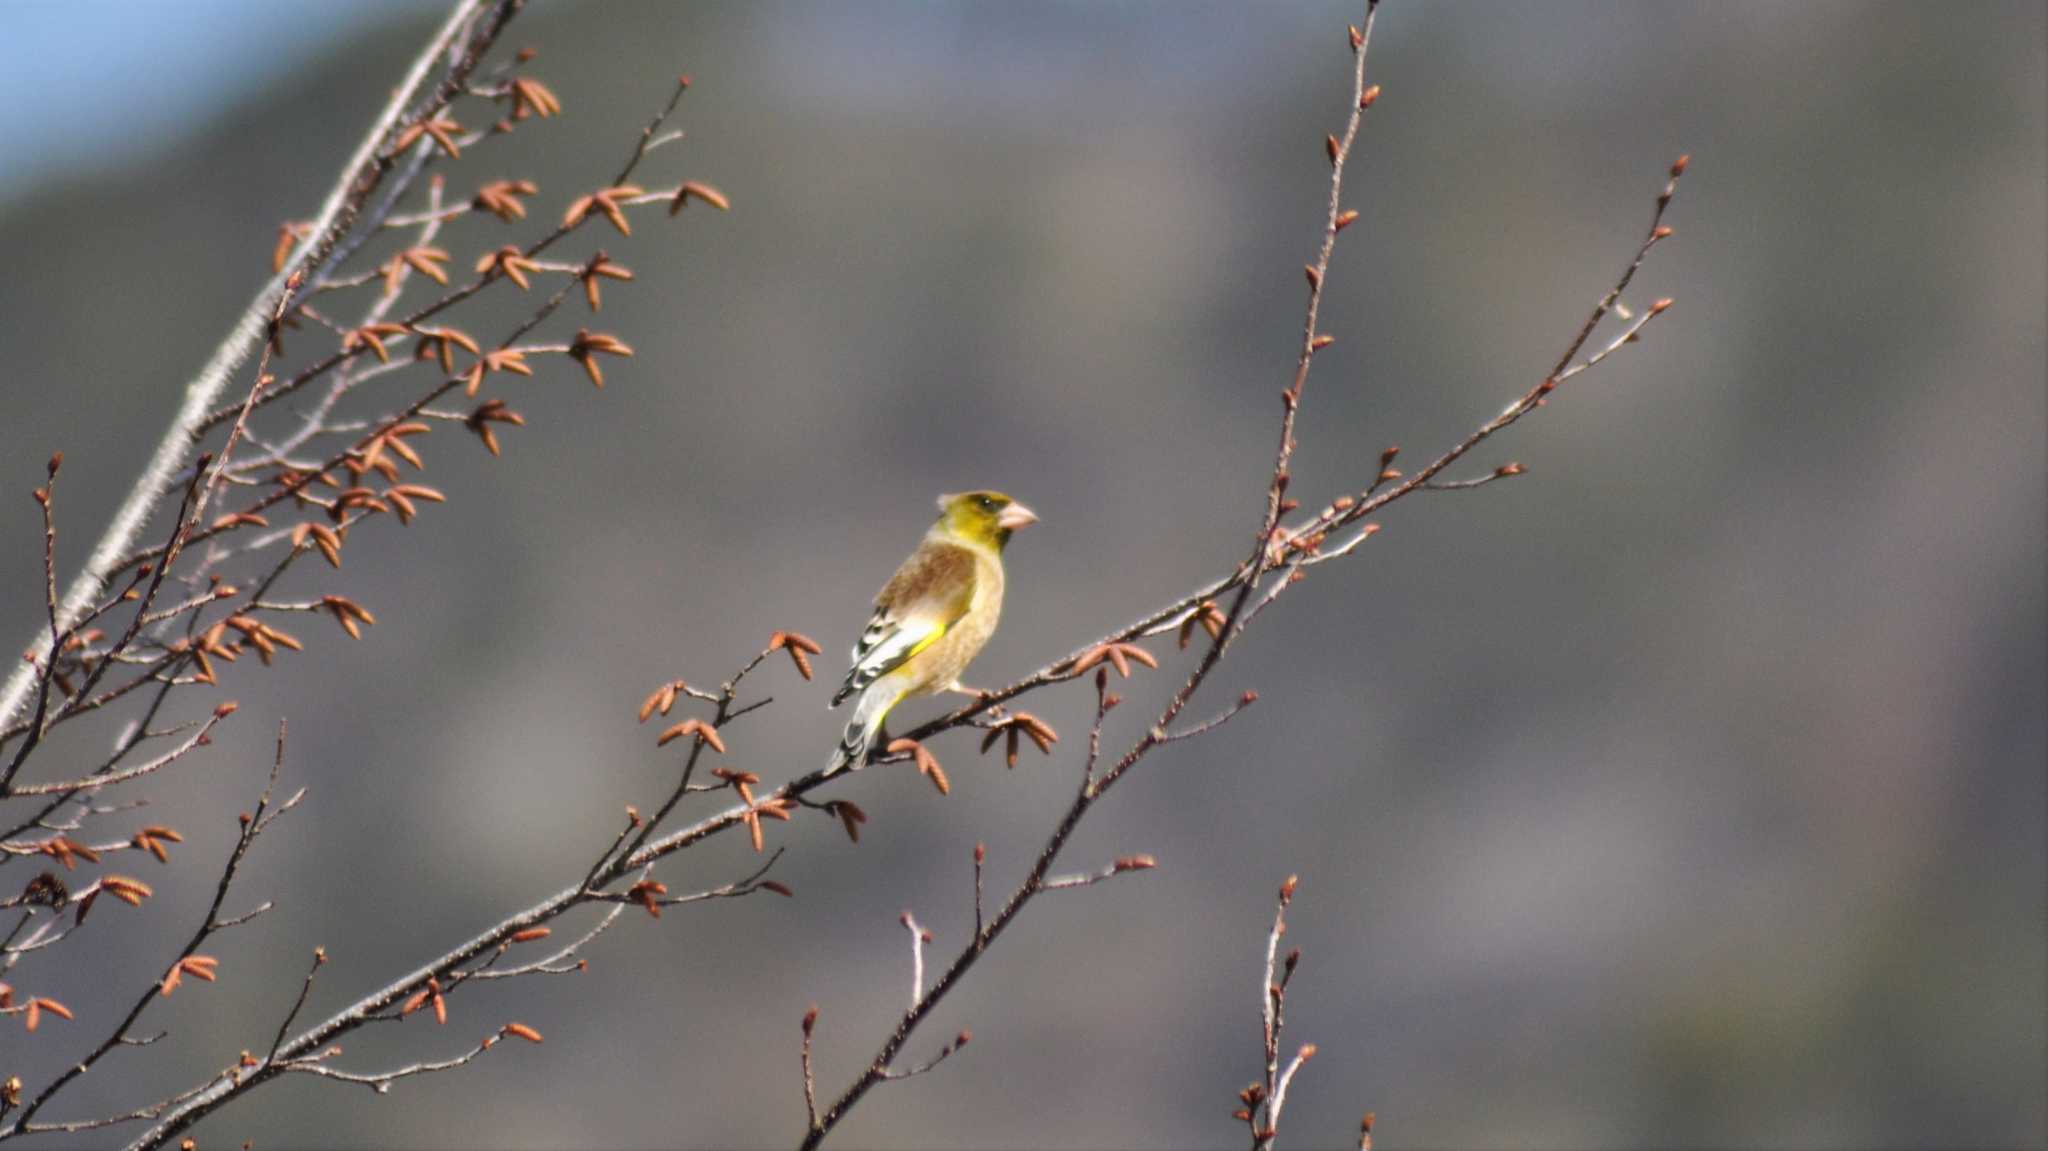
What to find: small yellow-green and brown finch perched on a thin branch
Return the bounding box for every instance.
[825,492,1038,774]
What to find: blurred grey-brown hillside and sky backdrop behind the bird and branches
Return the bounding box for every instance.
[0,0,2048,1147]
